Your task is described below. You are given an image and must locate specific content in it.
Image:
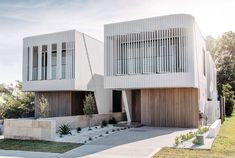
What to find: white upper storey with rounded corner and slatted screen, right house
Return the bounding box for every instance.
[104,14,207,89]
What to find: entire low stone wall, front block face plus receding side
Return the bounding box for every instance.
[4,112,124,140]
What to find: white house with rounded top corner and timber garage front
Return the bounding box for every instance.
[104,14,217,127]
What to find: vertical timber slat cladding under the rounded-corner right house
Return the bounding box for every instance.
[141,88,199,127]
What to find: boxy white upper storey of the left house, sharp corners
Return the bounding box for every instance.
[23,30,104,91]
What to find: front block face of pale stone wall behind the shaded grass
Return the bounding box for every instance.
[4,119,56,140]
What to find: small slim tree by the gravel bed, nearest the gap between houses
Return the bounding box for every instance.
[83,94,96,129]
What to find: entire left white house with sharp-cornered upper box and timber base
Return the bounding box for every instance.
[23,30,113,117]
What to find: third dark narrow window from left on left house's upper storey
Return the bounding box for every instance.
[51,44,57,79]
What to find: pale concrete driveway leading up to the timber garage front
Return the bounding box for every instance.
[56,127,193,158]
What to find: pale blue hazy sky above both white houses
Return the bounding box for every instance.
[0,0,235,84]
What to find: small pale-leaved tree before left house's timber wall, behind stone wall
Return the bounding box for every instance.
[38,95,49,117]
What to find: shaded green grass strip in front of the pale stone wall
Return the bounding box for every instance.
[0,139,82,153]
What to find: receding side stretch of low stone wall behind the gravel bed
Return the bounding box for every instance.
[39,112,124,130]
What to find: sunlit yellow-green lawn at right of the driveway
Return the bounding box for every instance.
[153,112,235,158]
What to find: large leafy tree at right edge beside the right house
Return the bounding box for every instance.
[206,31,235,95]
